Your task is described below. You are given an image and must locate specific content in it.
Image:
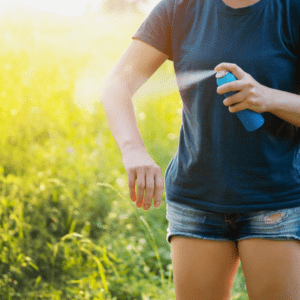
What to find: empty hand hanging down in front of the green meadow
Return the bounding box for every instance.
[122,148,164,210]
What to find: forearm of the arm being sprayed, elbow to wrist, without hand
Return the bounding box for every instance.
[100,77,145,154]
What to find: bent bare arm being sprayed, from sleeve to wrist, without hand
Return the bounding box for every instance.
[100,39,168,153]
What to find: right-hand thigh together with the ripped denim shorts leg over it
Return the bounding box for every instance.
[237,207,300,300]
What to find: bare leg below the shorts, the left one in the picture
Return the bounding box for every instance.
[170,236,239,300]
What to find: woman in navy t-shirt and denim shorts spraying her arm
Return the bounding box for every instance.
[101,0,300,300]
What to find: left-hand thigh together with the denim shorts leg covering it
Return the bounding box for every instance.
[167,202,239,300]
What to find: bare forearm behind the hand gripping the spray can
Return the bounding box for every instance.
[268,90,300,127]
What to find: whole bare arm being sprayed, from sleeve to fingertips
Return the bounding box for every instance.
[101,39,168,210]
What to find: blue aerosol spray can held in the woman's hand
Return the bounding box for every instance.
[216,71,264,131]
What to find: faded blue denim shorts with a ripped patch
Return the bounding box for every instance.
[166,200,300,246]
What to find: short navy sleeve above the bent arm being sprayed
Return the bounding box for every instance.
[132,0,173,61]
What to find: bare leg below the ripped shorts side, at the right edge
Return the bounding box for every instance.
[238,238,300,300]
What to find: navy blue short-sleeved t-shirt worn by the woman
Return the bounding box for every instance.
[132,0,300,213]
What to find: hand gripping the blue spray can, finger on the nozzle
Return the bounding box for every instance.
[215,63,273,113]
